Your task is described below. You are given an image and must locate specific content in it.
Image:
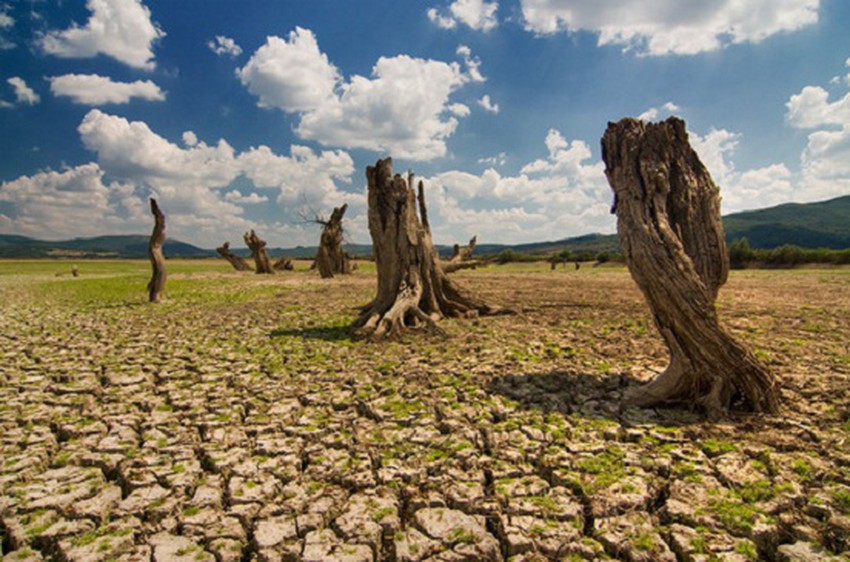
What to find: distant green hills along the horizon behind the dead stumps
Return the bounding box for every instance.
[0,196,850,258]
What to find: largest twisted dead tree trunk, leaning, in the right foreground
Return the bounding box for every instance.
[602,118,779,417]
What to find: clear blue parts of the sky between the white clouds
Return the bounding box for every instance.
[0,0,850,245]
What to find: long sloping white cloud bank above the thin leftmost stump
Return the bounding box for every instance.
[71,109,366,247]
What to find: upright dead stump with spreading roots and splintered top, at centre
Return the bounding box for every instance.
[356,158,503,338]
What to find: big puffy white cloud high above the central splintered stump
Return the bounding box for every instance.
[237,28,476,160]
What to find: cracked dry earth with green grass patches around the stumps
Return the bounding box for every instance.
[0,261,850,562]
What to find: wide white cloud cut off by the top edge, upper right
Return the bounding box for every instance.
[520,0,820,56]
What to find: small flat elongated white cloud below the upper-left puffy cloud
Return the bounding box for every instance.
[49,74,165,105]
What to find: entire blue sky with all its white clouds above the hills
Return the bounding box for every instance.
[0,0,850,247]
